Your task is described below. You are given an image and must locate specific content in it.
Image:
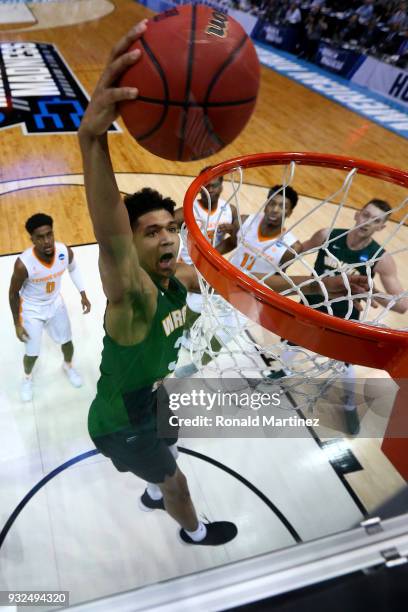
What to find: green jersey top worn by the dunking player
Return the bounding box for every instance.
[88,277,187,437]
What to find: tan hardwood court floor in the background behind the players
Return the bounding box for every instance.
[0,0,408,253]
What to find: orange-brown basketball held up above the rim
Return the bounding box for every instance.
[120,5,260,161]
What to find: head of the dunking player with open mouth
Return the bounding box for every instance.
[124,187,180,278]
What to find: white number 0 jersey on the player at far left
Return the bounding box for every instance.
[20,242,68,305]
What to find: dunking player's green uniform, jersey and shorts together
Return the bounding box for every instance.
[88,277,187,482]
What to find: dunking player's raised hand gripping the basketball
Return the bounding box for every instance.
[80,19,147,136]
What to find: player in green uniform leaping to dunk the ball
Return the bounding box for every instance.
[79,21,370,545]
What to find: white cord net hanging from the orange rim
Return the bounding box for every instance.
[182,162,408,408]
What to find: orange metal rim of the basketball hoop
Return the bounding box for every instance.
[184,153,408,378]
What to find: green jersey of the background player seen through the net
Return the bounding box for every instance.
[307,229,384,319]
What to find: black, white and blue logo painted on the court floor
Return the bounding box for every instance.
[0,42,118,134]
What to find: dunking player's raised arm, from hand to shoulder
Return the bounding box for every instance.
[79,21,146,301]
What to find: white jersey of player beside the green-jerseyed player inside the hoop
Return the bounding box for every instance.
[230,213,297,274]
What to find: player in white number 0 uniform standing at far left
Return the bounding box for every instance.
[9,213,91,402]
